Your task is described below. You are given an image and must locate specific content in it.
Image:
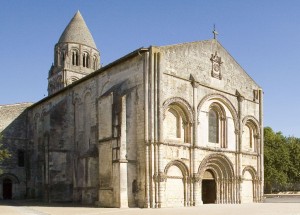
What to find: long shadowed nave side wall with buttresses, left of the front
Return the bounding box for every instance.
[28,52,143,207]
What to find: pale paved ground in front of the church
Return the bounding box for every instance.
[0,197,300,215]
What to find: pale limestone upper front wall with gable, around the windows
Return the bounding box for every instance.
[159,40,260,206]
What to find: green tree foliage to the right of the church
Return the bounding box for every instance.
[264,127,300,193]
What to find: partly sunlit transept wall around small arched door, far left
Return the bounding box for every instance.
[0,103,32,199]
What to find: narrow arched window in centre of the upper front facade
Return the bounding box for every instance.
[208,109,219,143]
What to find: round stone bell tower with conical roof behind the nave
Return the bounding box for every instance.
[48,11,100,95]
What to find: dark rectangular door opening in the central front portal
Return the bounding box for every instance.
[202,179,217,204]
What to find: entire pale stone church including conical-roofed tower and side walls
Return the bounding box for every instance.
[0,12,264,208]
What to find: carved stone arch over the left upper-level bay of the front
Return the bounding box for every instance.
[162,97,193,122]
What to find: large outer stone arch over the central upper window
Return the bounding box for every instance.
[197,93,238,129]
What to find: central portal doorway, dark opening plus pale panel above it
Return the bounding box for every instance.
[202,170,217,204]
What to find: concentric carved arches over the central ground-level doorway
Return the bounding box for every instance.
[197,153,235,179]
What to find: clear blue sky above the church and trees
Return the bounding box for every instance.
[0,0,300,137]
